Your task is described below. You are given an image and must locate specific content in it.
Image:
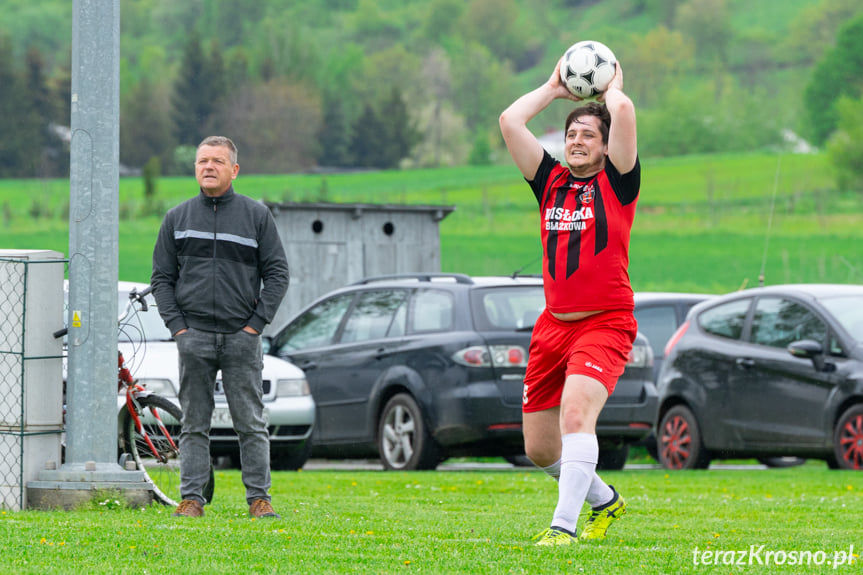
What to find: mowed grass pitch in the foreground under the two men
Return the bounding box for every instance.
[0,462,863,575]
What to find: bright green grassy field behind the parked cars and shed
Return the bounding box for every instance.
[0,154,863,293]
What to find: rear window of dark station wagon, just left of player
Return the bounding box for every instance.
[471,285,545,331]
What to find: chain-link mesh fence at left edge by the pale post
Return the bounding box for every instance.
[0,258,63,509]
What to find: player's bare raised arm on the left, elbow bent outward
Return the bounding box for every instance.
[500,61,579,180]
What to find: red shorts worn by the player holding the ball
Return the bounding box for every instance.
[522,310,638,413]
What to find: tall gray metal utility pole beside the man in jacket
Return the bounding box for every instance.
[31,0,153,504]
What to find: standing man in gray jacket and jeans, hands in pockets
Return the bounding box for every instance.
[151,136,288,517]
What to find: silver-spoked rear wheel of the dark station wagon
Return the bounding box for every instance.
[378,393,440,471]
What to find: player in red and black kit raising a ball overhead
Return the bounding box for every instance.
[500,56,641,545]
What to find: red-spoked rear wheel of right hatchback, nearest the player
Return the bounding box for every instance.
[657,405,710,469]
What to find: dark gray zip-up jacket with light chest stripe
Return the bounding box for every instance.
[150,186,289,334]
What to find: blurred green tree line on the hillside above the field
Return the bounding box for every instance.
[0,0,863,189]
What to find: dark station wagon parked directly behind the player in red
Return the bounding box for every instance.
[268,274,656,470]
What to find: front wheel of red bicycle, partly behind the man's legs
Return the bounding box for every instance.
[123,395,183,505]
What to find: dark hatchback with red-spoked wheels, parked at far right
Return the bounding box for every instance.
[656,284,863,469]
